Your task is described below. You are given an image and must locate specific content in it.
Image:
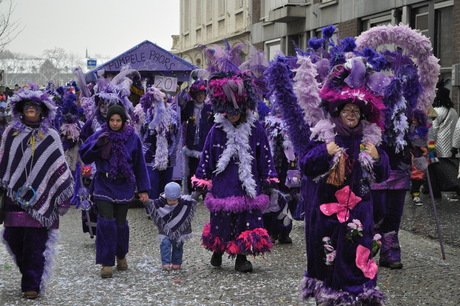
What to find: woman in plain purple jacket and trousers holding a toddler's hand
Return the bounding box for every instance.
[79,105,150,278]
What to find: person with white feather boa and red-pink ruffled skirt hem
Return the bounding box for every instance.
[192,72,277,272]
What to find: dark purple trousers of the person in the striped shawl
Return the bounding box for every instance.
[3,227,55,292]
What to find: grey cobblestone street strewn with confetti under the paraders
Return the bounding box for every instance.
[0,195,460,305]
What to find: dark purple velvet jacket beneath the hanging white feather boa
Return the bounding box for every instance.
[195,117,277,203]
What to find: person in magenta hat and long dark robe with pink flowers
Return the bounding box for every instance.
[300,59,389,305]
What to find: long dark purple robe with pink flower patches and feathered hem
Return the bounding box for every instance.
[300,121,389,304]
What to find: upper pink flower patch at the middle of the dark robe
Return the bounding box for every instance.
[319,186,361,223]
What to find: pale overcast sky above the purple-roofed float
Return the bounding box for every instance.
[6,0,180,58]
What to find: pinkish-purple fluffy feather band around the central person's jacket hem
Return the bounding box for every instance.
[204,193,270,213]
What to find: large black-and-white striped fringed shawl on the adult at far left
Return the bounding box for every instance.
[0,126,73,227]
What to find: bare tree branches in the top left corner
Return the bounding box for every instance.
[0,0,23,52]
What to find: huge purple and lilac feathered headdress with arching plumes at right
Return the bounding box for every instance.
[266,24,439,154]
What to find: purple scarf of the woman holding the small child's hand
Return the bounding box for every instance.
[101,123,135,182]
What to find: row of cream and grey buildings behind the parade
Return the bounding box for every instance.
[174,0,460,105]
